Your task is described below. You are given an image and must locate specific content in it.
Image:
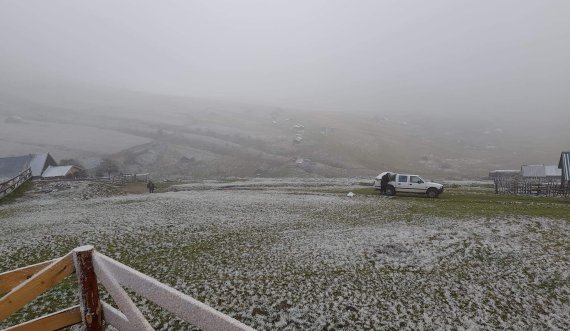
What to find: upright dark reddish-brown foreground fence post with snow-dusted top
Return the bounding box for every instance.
[73,245,103,331]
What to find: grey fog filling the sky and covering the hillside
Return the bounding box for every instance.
[0,0,570,178]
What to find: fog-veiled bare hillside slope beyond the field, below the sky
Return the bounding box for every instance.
[0,86,570,178]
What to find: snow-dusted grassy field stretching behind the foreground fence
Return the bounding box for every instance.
[0,186,570,330]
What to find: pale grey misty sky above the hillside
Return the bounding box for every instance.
[0,0,570,113]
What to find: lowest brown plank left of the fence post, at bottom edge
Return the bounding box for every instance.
[4,305,81,331]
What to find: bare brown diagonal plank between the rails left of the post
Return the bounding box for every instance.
[0,253,75,322]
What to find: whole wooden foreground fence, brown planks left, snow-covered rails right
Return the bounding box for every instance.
[0,246,253,331]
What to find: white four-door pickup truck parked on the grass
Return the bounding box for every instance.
[374,172,443,198]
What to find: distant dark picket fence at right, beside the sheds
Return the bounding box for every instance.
[494,177,570,197]
